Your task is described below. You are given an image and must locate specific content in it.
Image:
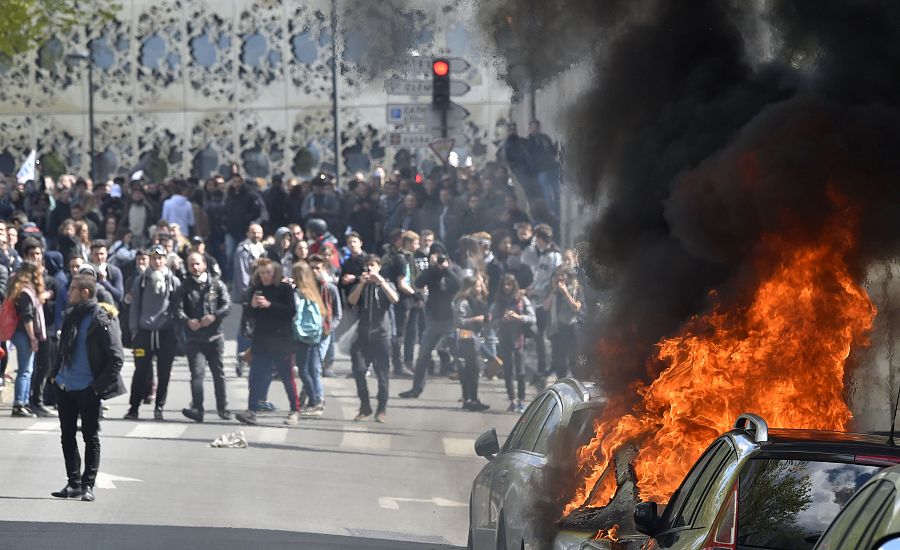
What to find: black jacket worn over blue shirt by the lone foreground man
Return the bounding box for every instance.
[50,305,127,399]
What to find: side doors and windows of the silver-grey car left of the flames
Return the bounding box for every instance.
[476,392,548,549]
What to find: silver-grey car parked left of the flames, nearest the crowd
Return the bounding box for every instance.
[468,378,606,550]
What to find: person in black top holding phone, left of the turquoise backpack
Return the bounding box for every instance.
[235,258,300,425]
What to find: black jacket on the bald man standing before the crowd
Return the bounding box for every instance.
[175,274,231,342]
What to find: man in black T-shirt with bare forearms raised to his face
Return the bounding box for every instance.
[347,254,400,423]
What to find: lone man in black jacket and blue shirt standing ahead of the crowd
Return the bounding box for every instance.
[51,275,126,501]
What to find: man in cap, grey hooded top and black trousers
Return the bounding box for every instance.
[125,245,180,420]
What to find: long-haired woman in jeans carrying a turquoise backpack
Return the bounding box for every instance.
[286,262,326,425]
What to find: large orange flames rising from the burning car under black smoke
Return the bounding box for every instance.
[564,216,876,515]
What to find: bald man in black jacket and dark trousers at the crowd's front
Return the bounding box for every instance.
[175,252,231,422]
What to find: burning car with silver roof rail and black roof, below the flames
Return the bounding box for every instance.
[555,414,900,550]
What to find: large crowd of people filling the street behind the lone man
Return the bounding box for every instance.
[0,121,586,425]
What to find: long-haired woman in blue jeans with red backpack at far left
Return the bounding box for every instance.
[6,262,47,418]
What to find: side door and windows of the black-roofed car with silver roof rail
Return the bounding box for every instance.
[654,439,737,548]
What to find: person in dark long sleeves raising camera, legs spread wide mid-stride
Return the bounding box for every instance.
[400,242,460,399]
